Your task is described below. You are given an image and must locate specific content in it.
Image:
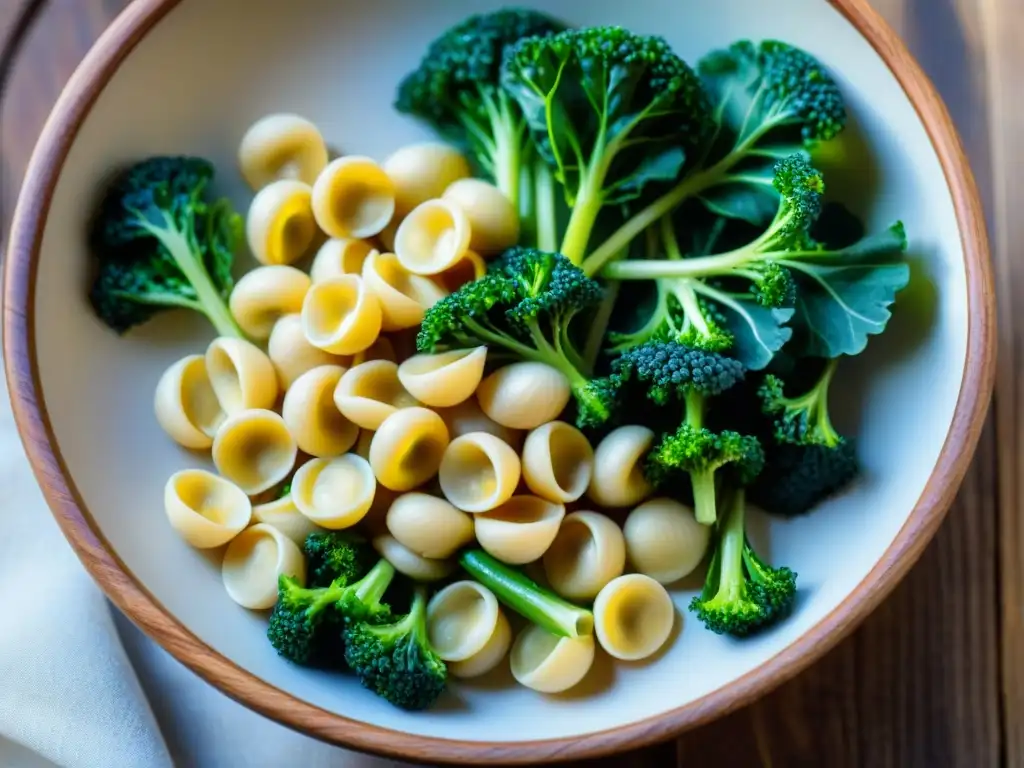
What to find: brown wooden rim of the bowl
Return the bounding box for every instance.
[3,0,996,765]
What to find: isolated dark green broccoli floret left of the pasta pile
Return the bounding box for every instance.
[89,157,243,337]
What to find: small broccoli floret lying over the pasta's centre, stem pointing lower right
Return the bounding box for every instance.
[417,248,615,426]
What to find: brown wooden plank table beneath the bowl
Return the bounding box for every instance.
[0,0,1011,768]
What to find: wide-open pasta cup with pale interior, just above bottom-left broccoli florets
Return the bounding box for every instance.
[292,454,377,530]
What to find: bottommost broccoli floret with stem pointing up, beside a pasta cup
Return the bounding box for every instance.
[345,586,447,710]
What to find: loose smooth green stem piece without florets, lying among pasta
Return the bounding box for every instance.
[459,549,594,637]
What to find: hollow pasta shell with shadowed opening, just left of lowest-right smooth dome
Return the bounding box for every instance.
[544,512,626,600]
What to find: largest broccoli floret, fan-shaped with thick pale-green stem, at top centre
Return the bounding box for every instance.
[502,27,711,274]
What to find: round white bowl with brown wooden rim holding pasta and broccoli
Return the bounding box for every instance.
[3,0,994,764]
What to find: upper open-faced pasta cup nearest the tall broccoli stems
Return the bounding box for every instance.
[394,200,470,274]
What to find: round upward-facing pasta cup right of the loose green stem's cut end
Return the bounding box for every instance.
[593,573,676,662]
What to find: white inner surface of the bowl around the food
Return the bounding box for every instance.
[25,0,967,741]
